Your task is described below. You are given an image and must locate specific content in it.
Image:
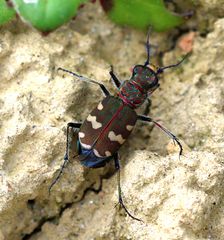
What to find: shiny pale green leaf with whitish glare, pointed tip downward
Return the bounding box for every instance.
[12,0,86,32]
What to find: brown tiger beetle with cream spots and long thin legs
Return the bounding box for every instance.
[49,33,188,221]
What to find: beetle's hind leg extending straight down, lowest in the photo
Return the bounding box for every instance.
[114,153,142,222]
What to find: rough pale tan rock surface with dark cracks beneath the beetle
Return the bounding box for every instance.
[0,1,224,240]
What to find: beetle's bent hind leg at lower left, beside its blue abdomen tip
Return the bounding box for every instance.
[48,122,82,194]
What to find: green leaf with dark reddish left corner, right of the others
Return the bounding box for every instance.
[101,0,183,31]
